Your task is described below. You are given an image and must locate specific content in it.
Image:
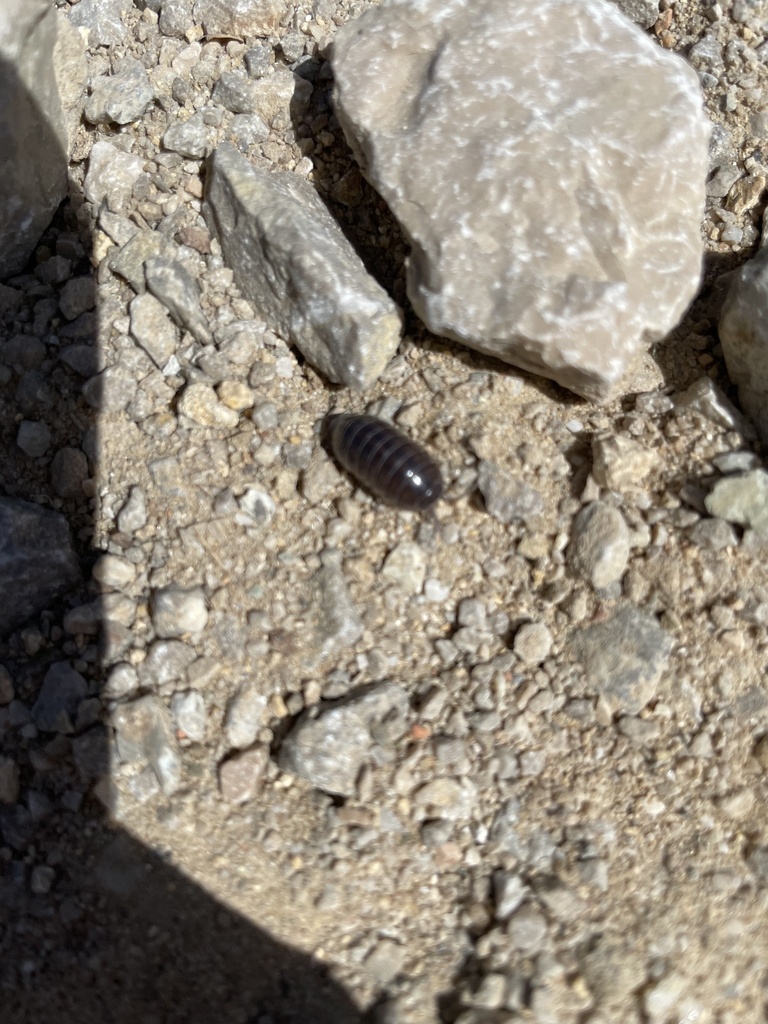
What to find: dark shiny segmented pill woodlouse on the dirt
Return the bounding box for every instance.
[328,414,442,512]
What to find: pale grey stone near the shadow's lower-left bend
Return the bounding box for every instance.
[113,696,181,797]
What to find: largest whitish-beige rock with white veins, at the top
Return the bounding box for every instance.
[332,0,709,400]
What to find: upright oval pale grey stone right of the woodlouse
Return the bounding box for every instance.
[568,502,630,590]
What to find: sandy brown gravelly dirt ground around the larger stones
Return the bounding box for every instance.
[0,0,768,1024]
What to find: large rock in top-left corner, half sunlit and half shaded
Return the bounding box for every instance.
[0,0,85,276]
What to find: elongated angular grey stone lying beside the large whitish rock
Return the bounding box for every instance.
[207,144,400,389]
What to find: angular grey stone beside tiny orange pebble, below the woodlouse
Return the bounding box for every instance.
[278,683,409,797]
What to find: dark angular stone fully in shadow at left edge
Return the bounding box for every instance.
[0,498,80,634]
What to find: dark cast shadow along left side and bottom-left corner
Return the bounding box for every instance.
[0,51,361,1024]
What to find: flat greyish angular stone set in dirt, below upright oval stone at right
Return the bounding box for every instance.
[572,605,672,715]
